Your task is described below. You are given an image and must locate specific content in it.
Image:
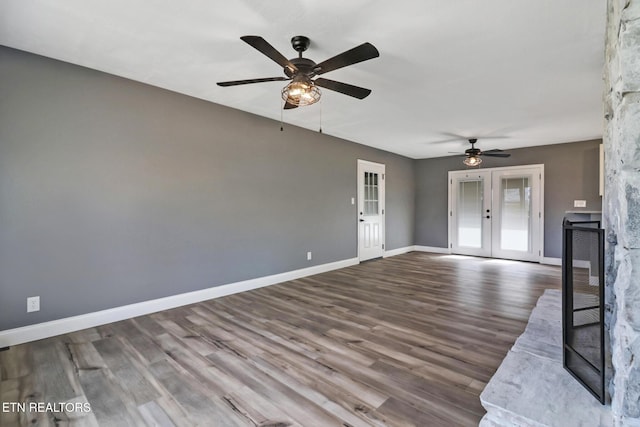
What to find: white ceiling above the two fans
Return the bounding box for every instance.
[0,0,606,158]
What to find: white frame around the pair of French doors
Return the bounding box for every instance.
[447,164,544,262]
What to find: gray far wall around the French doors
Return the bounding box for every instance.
[415,140,602,258]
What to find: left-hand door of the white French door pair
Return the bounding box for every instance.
[449,170,491,257]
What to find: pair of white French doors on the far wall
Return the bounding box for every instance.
[449,165,544,261]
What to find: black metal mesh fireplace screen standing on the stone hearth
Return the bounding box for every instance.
[562,219,605,404]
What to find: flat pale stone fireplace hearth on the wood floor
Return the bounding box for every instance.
[480,289,613,427]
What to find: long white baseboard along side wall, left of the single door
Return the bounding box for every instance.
[0,258,359,348]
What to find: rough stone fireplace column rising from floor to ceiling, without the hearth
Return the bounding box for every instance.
[603,0,640,426]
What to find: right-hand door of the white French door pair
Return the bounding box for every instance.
[492,167,542,261]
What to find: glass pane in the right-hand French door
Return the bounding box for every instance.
[500,177,531,252]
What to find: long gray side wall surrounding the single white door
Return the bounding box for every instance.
[0,47,415,330]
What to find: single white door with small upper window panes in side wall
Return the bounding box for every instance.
[358,160,385,261]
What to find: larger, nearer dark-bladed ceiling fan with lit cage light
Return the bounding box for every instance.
[218,36,380,109]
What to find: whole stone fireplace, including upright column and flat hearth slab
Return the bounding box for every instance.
[481,0,640,427]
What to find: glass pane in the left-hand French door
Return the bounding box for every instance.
[458,180,483,248]
